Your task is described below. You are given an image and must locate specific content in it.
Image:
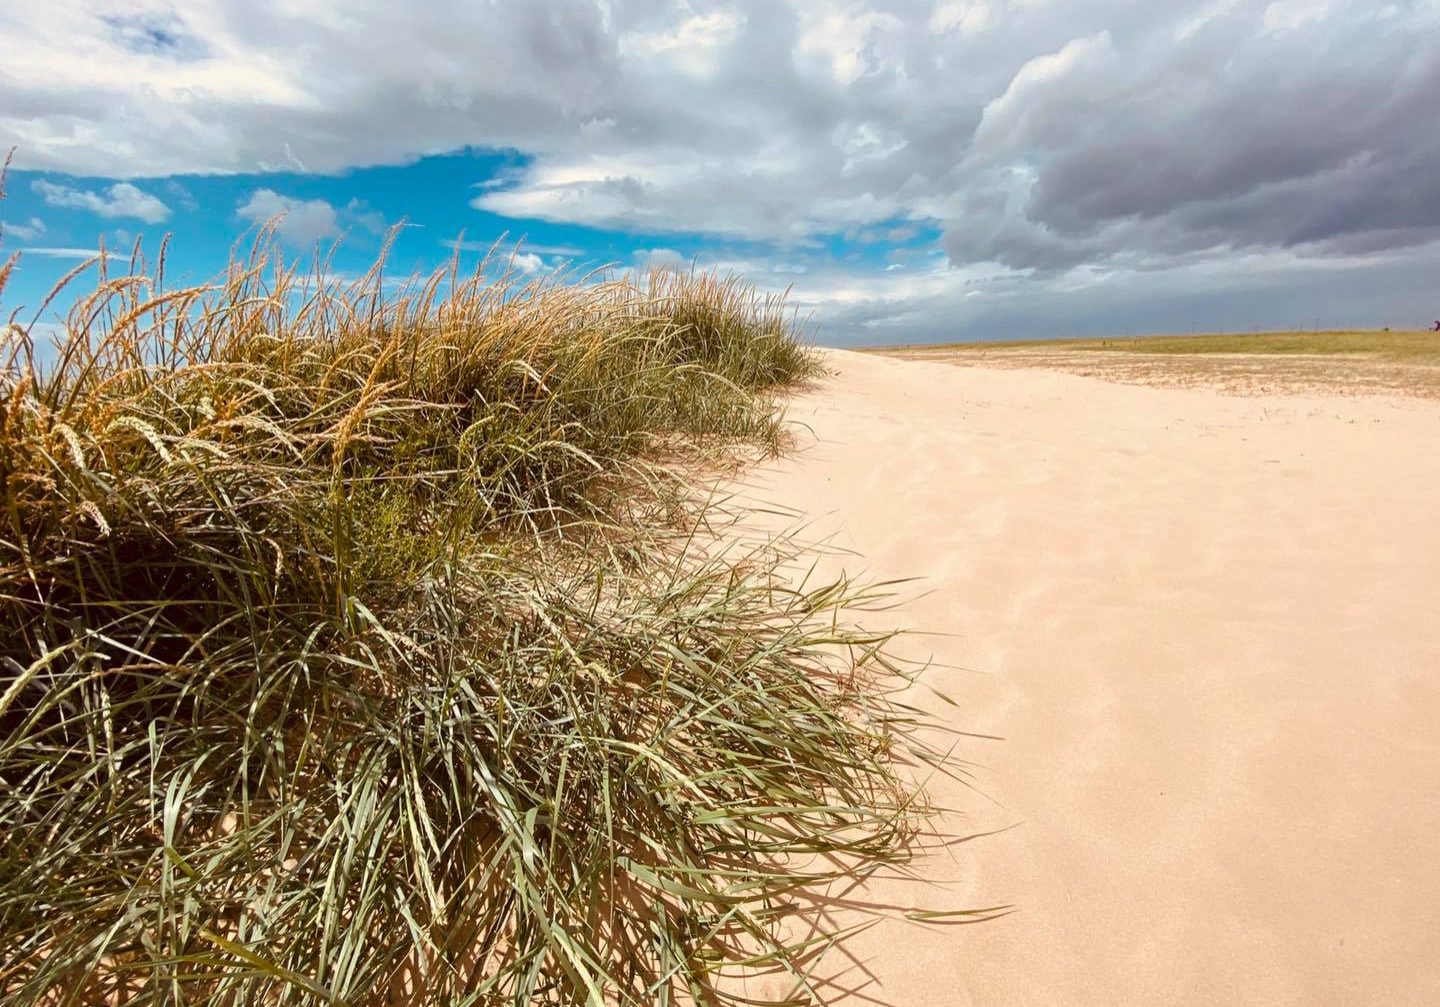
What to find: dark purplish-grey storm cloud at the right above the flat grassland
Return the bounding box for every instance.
[952,6,1440,267]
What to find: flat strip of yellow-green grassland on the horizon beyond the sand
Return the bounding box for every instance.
[870,330,1440,399]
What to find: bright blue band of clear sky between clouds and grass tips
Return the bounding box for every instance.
[8,150,943,341]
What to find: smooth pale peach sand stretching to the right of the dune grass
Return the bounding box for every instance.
[731,353,1440,1007]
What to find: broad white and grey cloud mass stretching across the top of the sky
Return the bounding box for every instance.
[0,0,1440,338]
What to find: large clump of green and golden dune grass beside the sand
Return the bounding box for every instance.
[0,216,930,1007]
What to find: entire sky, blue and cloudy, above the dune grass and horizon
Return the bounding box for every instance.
[0,0,1440,346]
